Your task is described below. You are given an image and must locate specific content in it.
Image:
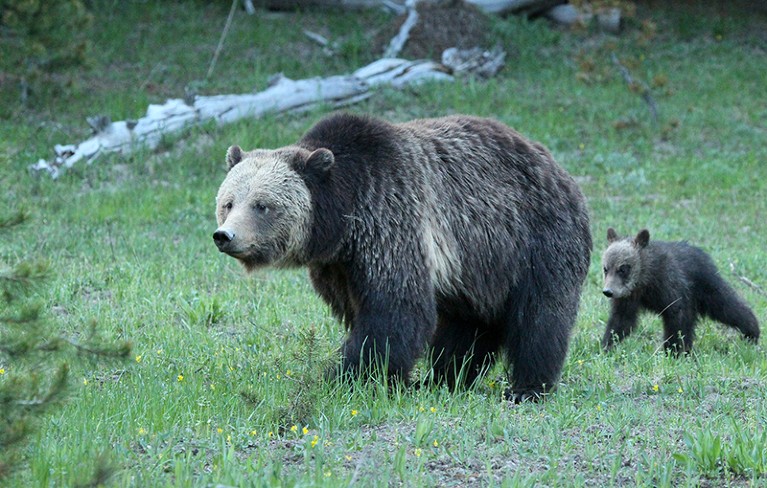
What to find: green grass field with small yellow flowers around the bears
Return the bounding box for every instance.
[0,0,767,486]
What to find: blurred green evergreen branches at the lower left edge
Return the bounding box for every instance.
[0,213,130,480]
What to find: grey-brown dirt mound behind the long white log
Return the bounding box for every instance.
[373,0,491,60]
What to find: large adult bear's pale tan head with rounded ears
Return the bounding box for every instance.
[213,146,335,271]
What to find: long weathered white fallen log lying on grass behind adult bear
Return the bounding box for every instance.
[30,59,452,178]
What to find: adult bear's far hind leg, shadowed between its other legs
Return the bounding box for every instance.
[431,318,502,389]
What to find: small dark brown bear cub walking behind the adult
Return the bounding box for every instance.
[602,228,759,354]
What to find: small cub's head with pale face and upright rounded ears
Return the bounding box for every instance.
[602,227,650,298]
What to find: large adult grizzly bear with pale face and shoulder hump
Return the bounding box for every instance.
[213,114,591,400]
